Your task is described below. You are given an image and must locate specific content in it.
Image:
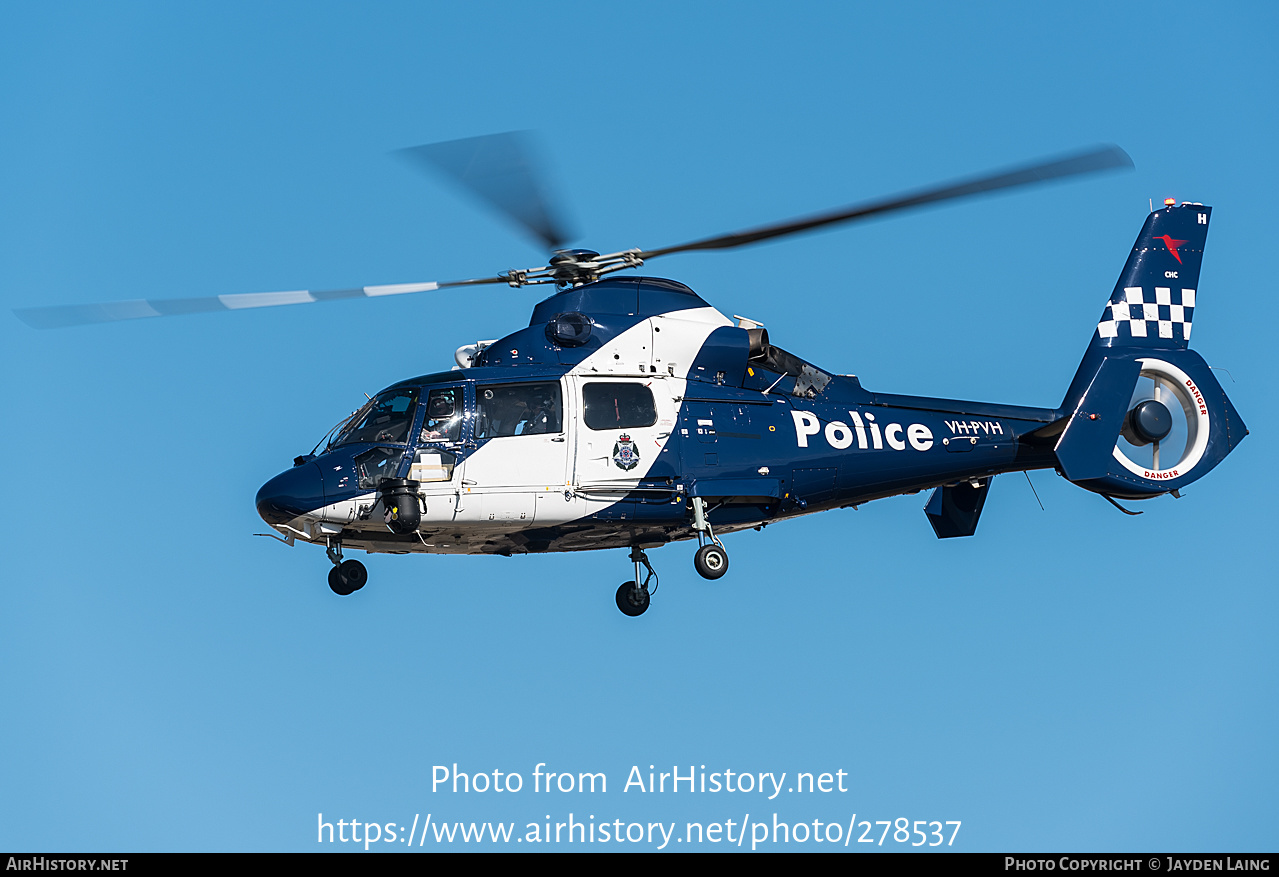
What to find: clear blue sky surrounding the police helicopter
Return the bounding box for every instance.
[0,3,1279,851]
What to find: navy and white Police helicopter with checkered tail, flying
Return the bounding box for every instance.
[15,133,1248,616]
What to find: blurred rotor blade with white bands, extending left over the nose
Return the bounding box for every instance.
[14,277,506,329]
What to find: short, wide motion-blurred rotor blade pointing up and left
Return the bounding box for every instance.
[399,132,573,249]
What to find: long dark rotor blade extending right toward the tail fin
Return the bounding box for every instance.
[638,146,1133,260]
